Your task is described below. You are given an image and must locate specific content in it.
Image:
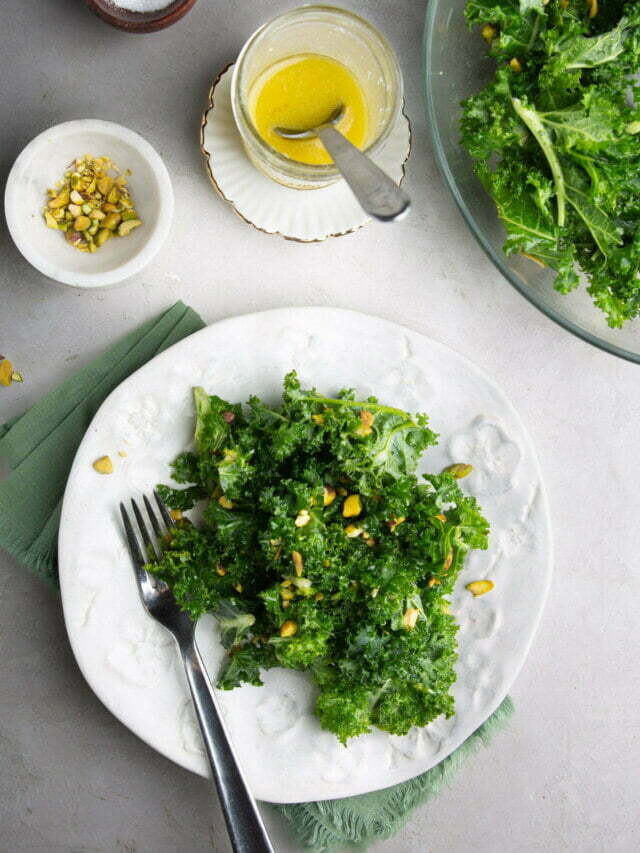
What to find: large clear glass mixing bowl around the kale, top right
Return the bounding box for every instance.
[424,0,640,363]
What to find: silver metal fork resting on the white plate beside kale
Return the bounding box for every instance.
[120,492,273,853]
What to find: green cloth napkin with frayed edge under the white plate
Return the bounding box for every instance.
[0,302,513,853]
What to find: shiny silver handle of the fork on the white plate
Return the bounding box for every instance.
[181,640,273,853]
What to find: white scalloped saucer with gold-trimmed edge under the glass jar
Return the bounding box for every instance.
[200,65,411,243]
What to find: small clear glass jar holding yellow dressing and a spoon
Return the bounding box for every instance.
[231,6,402,189]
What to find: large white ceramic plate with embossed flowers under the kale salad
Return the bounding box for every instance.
[60,308,551,802]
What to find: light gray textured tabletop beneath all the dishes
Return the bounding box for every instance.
[0,0,640,853]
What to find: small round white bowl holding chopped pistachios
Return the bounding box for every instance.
[5,119,173,288]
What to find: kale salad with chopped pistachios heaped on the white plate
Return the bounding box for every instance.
[148,373,488,743]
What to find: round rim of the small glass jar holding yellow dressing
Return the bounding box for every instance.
[231,3,404,181]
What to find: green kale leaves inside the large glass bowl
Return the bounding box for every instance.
[461,0,640,327]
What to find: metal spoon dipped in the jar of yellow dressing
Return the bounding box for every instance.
[273,104,411,222]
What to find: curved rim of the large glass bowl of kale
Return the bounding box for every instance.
[422,0,640,364]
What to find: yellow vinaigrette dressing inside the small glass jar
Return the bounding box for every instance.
[248,53,368,166]
